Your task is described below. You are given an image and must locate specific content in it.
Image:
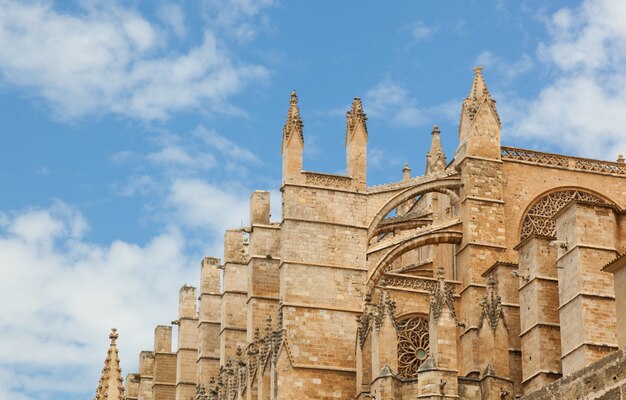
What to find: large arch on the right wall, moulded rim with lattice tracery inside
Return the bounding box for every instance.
[518,187,615,241]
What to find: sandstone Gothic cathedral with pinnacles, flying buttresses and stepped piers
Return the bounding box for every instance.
[96,67,626,400]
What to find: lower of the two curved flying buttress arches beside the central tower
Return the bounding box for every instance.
[366,229,463,293]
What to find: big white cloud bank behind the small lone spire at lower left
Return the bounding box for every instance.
[0,202,197,399]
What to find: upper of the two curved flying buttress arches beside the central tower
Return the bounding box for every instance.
[367,176,461,240]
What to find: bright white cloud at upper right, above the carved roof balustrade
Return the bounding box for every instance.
[501,0,626,159]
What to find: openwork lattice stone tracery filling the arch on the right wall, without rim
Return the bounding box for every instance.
[520,190,608,240]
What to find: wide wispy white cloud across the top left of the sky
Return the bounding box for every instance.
[0,0,267,120]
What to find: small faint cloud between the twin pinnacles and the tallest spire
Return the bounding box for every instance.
[363,80,460,127]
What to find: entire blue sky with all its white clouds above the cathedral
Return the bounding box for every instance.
[0,0,626,400]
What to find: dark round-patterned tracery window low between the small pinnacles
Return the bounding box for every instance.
[398,316,430,379]
